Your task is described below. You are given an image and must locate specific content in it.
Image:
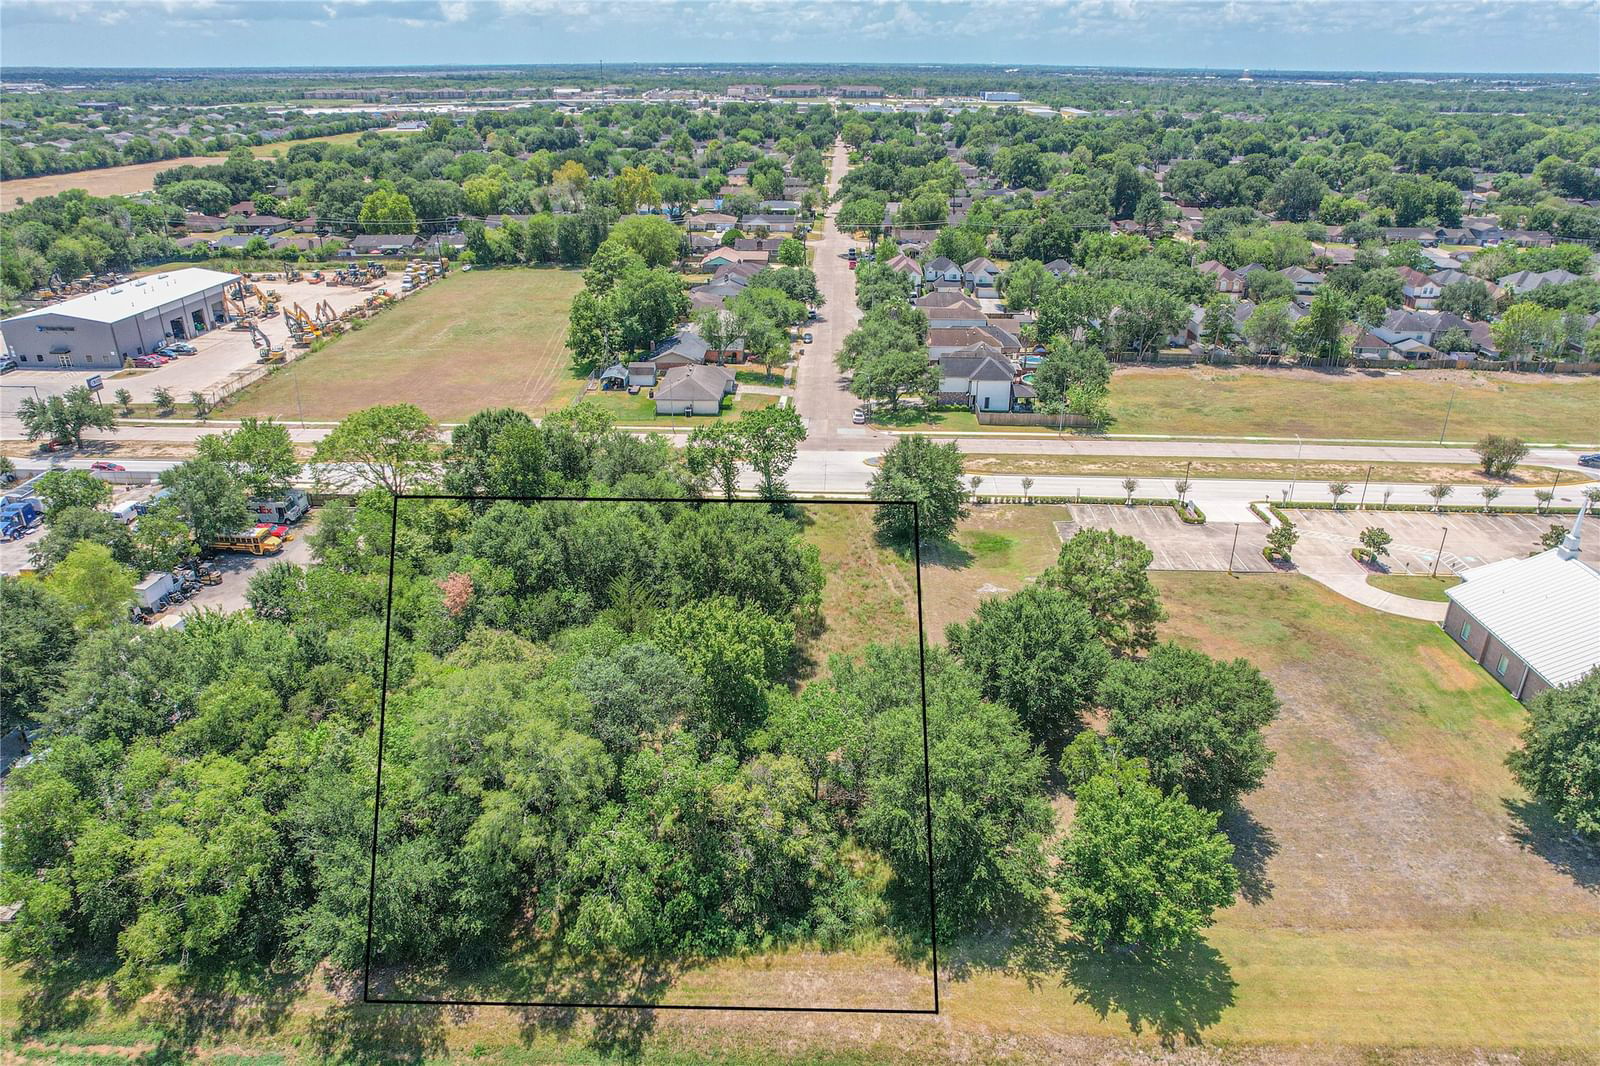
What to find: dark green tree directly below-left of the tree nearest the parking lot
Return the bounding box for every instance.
[946,586,1110,747]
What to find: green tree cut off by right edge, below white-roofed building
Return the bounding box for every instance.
[1507,671,1600,837]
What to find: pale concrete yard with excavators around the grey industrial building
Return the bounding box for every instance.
[0,271,400,406]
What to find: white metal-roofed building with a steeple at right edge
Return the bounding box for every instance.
[1445,503,1600,699]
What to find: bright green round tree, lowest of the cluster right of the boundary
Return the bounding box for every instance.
[1056,745,1238,952]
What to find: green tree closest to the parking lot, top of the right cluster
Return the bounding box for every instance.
[1040,530,1166,655]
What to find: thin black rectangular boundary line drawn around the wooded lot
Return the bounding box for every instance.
[362,493,939,1015]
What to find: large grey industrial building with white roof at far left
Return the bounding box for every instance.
[0,267,238,370]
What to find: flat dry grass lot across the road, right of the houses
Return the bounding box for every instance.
[1109,368,1600,443]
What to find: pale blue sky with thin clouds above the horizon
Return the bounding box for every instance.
[0,0,1600,74]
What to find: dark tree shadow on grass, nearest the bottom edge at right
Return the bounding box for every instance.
[1062,940,1238,1047]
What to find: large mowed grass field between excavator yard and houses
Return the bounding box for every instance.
[224,269,582,421]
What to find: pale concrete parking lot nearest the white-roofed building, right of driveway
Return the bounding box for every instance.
[1286,509,1600,573]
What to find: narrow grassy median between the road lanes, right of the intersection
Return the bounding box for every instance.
[962,455,1594,491]
